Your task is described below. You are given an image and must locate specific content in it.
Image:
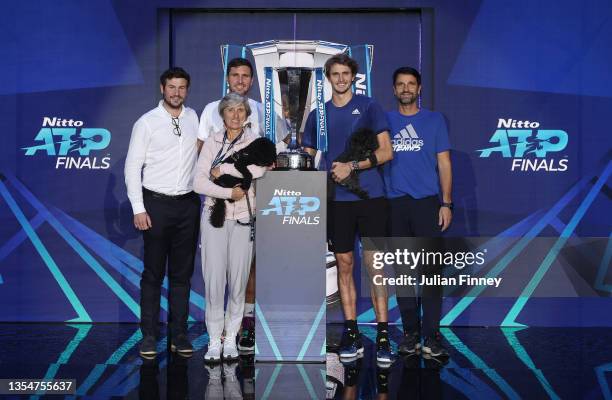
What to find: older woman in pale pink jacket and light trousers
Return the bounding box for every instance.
[193,93,266,362]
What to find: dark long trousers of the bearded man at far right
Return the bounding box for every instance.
[389,196,442,336]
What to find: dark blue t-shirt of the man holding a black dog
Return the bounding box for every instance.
[302,95,389,201]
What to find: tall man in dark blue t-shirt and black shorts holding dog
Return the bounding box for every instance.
[302,54,393,364]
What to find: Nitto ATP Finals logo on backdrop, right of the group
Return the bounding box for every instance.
[476,118,568,172]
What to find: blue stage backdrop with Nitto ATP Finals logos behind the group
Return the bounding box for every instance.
[0,0,612,326]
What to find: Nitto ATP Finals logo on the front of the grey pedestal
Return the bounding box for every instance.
[261,189,321,225]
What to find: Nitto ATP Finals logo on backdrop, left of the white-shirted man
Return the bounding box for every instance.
[22,117,111,169]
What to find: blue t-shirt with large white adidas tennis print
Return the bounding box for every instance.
[384,109,450,199]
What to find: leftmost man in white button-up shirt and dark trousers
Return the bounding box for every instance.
[125,68,200,359]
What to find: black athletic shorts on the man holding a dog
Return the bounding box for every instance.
[327,197,388,253]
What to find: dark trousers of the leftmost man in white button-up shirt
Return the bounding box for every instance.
[140,189,200,336]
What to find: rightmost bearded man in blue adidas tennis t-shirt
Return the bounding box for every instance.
[384,67,453,356]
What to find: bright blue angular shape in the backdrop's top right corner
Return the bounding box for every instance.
[448,0,612,97]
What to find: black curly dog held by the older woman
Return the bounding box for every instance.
[210,138,276,228]
